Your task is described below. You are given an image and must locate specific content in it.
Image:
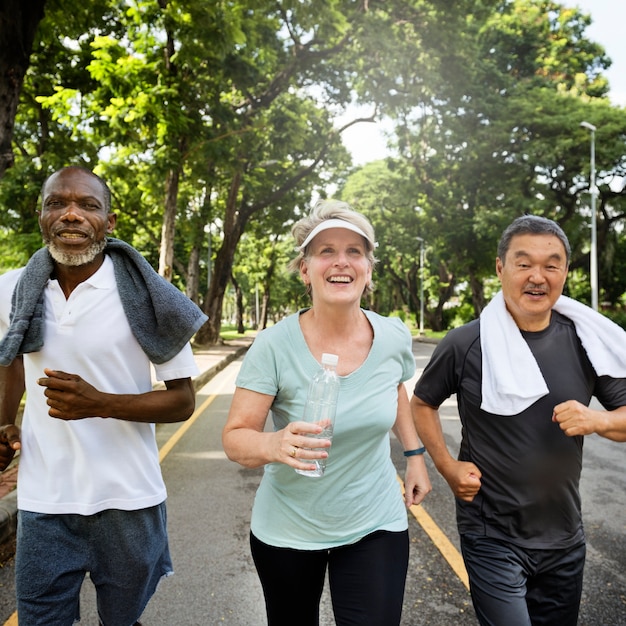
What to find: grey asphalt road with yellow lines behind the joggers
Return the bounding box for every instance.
[0,343,626,626]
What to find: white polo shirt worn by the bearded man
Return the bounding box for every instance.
[0,257,198,515]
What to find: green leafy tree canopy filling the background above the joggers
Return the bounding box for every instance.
[0,0,626,336]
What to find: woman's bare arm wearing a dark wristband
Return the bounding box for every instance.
[392,383,432,508]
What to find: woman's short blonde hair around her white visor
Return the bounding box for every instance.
[288,200,377,295]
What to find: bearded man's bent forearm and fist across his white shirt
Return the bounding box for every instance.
[37,369,195,423]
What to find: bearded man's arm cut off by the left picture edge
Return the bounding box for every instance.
[0,356,25,471]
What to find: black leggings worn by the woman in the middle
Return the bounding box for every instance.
[250,530,409,626]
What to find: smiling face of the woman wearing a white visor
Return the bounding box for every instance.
[300,228,372,304]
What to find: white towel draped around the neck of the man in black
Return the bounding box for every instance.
[480,291,626,415]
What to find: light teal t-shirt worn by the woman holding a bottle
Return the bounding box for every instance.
[236,311,415,550]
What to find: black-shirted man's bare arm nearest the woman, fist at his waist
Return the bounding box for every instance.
[411,395,481,502]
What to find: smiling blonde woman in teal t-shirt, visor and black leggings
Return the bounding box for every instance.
[223,200,431,626]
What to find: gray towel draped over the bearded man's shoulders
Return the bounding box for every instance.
[0,237,208,366]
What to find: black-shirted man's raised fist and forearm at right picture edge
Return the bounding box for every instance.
[552,400,626,441]
